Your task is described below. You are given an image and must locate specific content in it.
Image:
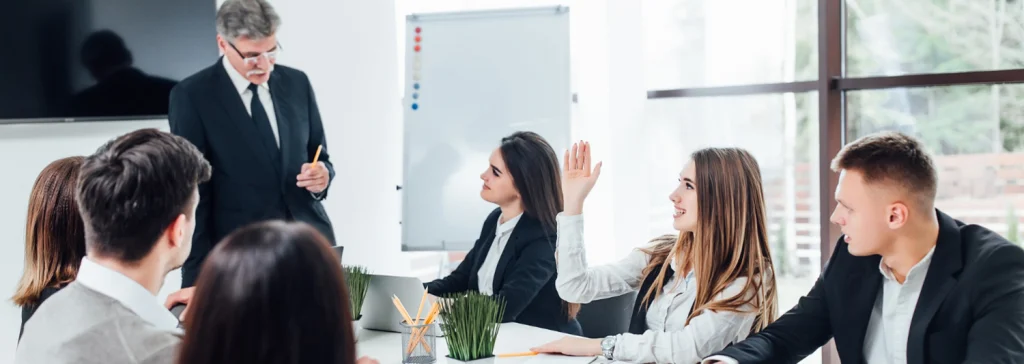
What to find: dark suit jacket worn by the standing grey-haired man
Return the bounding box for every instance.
[168,60,335,287]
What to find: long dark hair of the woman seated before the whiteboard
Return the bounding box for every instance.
[501,131,580,318]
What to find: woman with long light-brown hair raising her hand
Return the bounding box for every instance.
[534,141,777,363]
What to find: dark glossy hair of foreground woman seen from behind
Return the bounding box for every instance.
[177,221,355,364]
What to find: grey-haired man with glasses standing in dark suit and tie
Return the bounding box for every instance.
[168,0,335,291]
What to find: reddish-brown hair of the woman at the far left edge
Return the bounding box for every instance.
[12,157,85,306]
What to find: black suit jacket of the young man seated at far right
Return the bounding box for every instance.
[716,210,1024,364]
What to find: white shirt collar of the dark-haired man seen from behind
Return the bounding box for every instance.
[75,257,178,330]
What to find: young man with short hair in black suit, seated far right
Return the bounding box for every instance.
[705,133,1024,364]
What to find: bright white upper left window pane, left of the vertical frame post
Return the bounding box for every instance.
[643,0,818,89]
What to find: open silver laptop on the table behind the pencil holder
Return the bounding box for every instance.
[359,275,442,336]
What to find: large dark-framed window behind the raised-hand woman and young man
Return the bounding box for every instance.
[643,0,1024,363]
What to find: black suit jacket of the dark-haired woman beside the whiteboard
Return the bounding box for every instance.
[425,209,583,335]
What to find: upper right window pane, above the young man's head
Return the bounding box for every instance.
[846,0,1024,76]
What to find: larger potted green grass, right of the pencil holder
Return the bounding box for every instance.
[438,292,505,362]
